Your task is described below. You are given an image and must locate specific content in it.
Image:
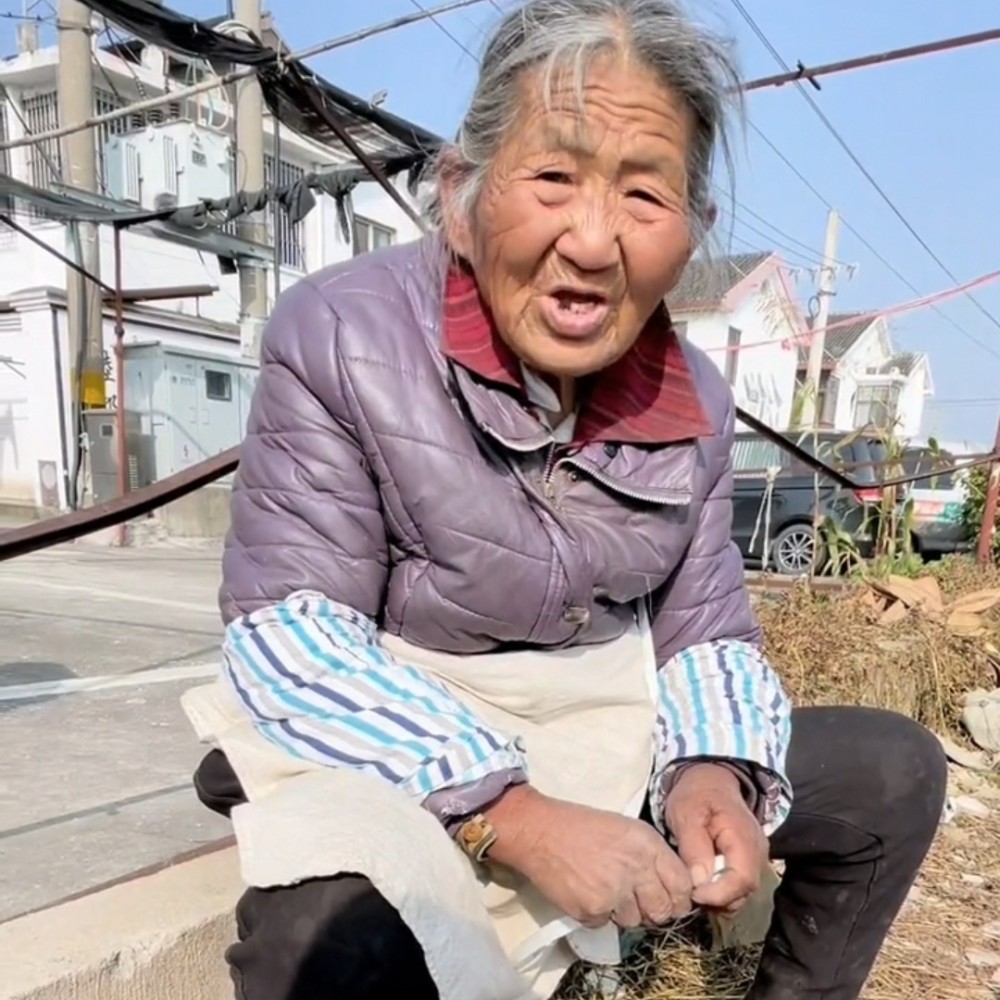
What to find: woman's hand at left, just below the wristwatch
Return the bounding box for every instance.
[486,785,692,927]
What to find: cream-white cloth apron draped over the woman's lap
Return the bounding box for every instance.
[183,609,657,1000]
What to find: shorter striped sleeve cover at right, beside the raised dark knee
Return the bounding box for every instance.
[650,640,792,836]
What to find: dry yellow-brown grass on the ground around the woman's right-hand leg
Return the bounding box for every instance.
[561,560,1000,1000]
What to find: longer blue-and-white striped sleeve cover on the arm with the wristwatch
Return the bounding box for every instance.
[223,592,525,811]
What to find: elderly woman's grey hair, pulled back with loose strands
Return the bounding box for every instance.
[427,0,740,242]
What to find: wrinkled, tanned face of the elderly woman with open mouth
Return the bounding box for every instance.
[442,57,693,377]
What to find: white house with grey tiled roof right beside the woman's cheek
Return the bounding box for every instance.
[667,252,804,429]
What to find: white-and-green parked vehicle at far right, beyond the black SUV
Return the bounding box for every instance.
[903,446,973,558]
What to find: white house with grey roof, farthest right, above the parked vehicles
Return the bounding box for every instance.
[800,313,934,439]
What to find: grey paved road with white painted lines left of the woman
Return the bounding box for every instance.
[0,546,229,920]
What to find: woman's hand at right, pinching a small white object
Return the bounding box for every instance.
[664,764,768,913]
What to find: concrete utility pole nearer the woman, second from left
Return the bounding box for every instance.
[233,0,268,355]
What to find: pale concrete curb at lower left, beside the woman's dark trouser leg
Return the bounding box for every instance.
[0,848,243,1000]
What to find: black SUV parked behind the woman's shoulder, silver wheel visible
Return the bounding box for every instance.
[732,431,886,576]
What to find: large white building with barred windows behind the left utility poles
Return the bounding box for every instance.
[0,23,419,509]
